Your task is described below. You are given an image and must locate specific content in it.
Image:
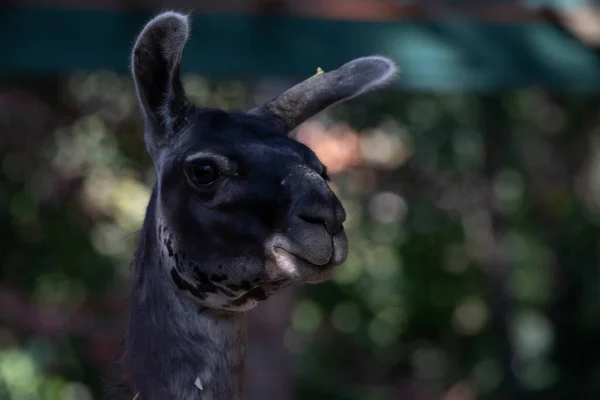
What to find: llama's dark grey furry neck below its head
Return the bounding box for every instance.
[124,191,246,400]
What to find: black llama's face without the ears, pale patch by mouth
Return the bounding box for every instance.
[158,109,348,310]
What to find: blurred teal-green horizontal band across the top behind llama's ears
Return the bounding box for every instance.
[0,6,600,92]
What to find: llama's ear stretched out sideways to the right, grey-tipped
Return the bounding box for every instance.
[249,56,398,132]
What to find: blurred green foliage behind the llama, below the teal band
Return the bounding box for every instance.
[0,71,600,400]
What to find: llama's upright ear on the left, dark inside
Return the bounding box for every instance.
[131,12,192,154]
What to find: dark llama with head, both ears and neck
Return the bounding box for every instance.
[122,12,397,400]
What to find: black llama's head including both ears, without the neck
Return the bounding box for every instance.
[132,12,397,311]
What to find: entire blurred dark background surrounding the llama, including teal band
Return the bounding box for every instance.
[0,0,600,400]
